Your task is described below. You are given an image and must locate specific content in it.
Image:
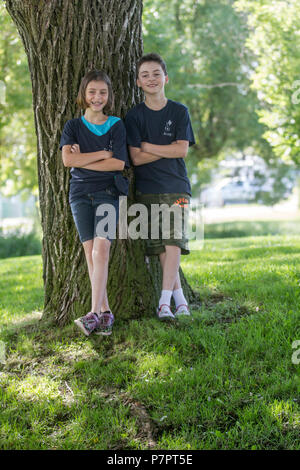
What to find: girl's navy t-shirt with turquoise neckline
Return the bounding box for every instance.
[59,116,129,202]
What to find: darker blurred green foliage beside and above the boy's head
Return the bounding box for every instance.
[143,0,270,166]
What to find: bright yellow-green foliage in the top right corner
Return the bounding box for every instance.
[235,0,300,163]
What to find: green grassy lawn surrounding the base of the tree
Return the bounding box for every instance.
[0,236,300,450]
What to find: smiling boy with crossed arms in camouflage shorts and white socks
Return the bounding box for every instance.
[125,54,195,319]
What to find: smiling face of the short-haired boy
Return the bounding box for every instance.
[137,62,169,94]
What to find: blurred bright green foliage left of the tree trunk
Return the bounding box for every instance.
[0,2,37,195]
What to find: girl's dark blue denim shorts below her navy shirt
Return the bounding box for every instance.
[70,186,119,243]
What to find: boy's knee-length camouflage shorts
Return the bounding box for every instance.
[136,192,190,255]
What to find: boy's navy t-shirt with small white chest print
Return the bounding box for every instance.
[125,100,195,194]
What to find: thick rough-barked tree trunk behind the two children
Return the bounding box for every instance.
[6,0,197,325]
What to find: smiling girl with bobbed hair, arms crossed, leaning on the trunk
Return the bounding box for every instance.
[60,70,128,336]
